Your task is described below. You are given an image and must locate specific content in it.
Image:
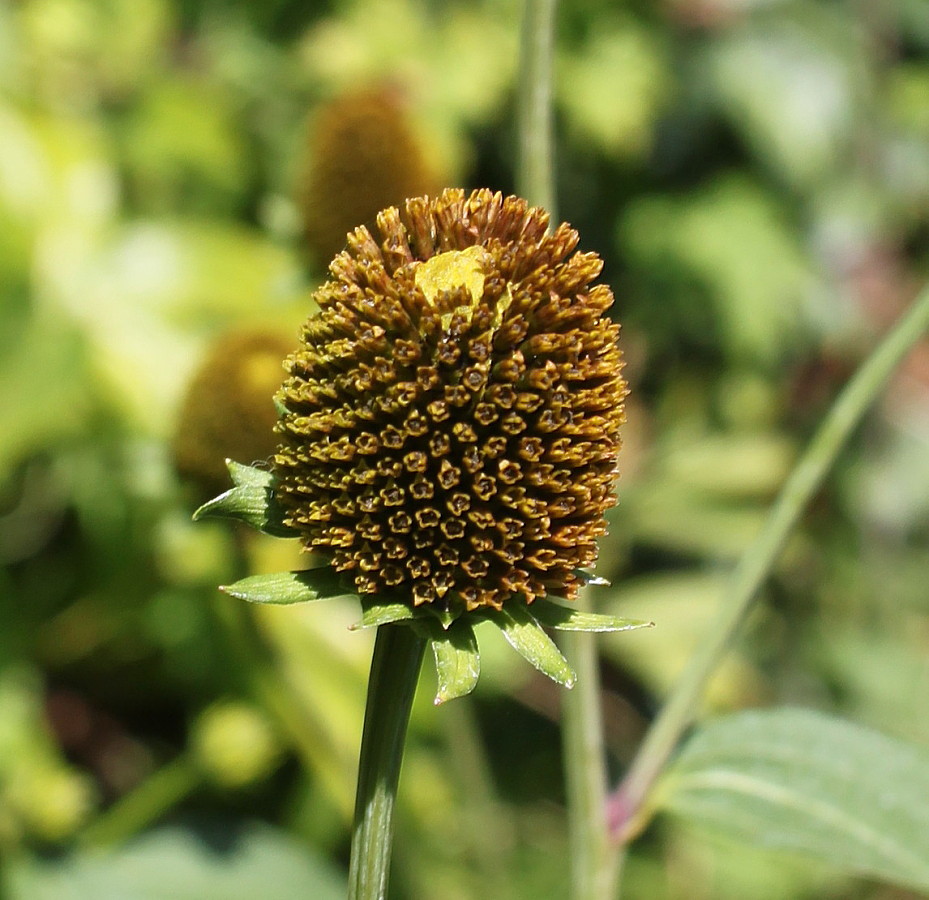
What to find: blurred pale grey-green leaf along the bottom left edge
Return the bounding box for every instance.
[6,822,346,900]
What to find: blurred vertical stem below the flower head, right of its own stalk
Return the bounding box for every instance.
[561,590,616,900]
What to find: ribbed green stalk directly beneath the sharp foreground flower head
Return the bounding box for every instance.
[348,625,426,900]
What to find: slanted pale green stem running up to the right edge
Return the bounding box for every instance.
[610,288,929,843]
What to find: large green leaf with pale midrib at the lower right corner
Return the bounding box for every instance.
[656,709,929,890]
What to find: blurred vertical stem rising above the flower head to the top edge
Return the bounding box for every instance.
[516,0,556,221]
